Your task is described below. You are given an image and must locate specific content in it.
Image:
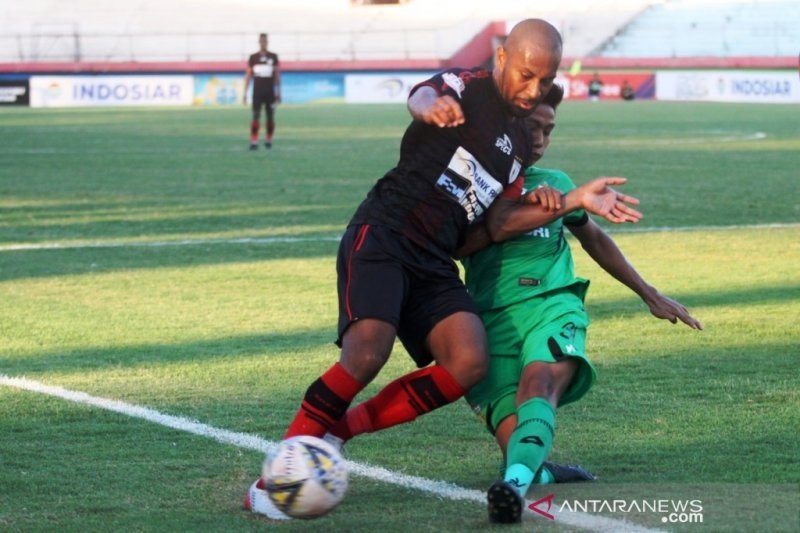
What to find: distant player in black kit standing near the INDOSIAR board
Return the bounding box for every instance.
[242,33,281,150]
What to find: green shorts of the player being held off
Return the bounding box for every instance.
[466,284,597,434]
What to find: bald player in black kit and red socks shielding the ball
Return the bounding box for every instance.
[247,19,641,524]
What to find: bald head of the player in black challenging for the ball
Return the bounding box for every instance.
[493,19,561,116]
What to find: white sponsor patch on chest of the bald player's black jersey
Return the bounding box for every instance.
[436,147,503,222]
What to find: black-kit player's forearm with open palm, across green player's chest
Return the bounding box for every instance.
[486,178,642,242]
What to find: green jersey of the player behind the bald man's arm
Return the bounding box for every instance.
[463,167,588,312]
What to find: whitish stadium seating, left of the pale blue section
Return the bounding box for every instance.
[0,0,641,62]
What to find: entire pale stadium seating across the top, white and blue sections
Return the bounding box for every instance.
[0,0,800,63]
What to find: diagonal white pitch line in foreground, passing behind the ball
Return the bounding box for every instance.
[0,374,660,533]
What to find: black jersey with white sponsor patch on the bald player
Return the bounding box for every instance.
[350,68,532,256]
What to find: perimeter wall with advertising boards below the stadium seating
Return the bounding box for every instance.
[0,56,800,107]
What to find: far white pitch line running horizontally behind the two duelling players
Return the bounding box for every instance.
[0,222,800,252]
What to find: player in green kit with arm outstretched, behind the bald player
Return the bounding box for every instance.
[459,85,702,523]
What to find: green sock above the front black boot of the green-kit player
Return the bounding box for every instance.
[503,398,556,497]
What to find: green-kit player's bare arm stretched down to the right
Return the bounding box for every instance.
[567,219,703,329]
